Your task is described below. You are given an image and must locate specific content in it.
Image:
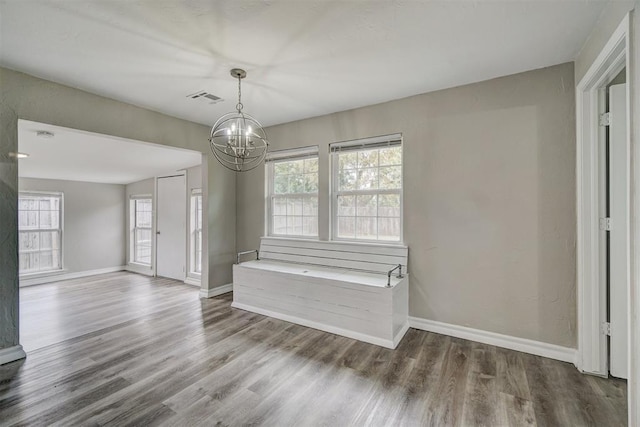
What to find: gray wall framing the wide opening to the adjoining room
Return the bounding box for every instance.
[0,68,236,349]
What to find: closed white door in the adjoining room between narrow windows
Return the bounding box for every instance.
[156,175,187,280]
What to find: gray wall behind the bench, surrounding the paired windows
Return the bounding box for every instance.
[237,63,576,347]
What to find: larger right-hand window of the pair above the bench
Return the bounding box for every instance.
[331,135,402,242]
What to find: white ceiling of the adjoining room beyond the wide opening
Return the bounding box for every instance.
[18,120,202,184]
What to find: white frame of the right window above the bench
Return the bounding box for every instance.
[329,134,404,246]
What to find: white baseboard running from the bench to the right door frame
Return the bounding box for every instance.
[409,317,577,365]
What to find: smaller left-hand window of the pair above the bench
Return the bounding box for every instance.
[267,147,318,237]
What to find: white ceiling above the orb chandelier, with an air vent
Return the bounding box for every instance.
[0,0,606,125]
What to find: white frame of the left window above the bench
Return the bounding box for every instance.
[265,145,320,240]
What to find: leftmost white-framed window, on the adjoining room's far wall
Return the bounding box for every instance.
[18,193,62,274]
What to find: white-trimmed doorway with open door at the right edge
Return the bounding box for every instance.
[576,10,639,424]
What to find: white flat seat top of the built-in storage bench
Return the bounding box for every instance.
[239,259,403,288]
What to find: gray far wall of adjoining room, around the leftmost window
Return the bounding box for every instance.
[18,178,125,273]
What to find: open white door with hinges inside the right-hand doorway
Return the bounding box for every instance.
[609,84,630,378]
